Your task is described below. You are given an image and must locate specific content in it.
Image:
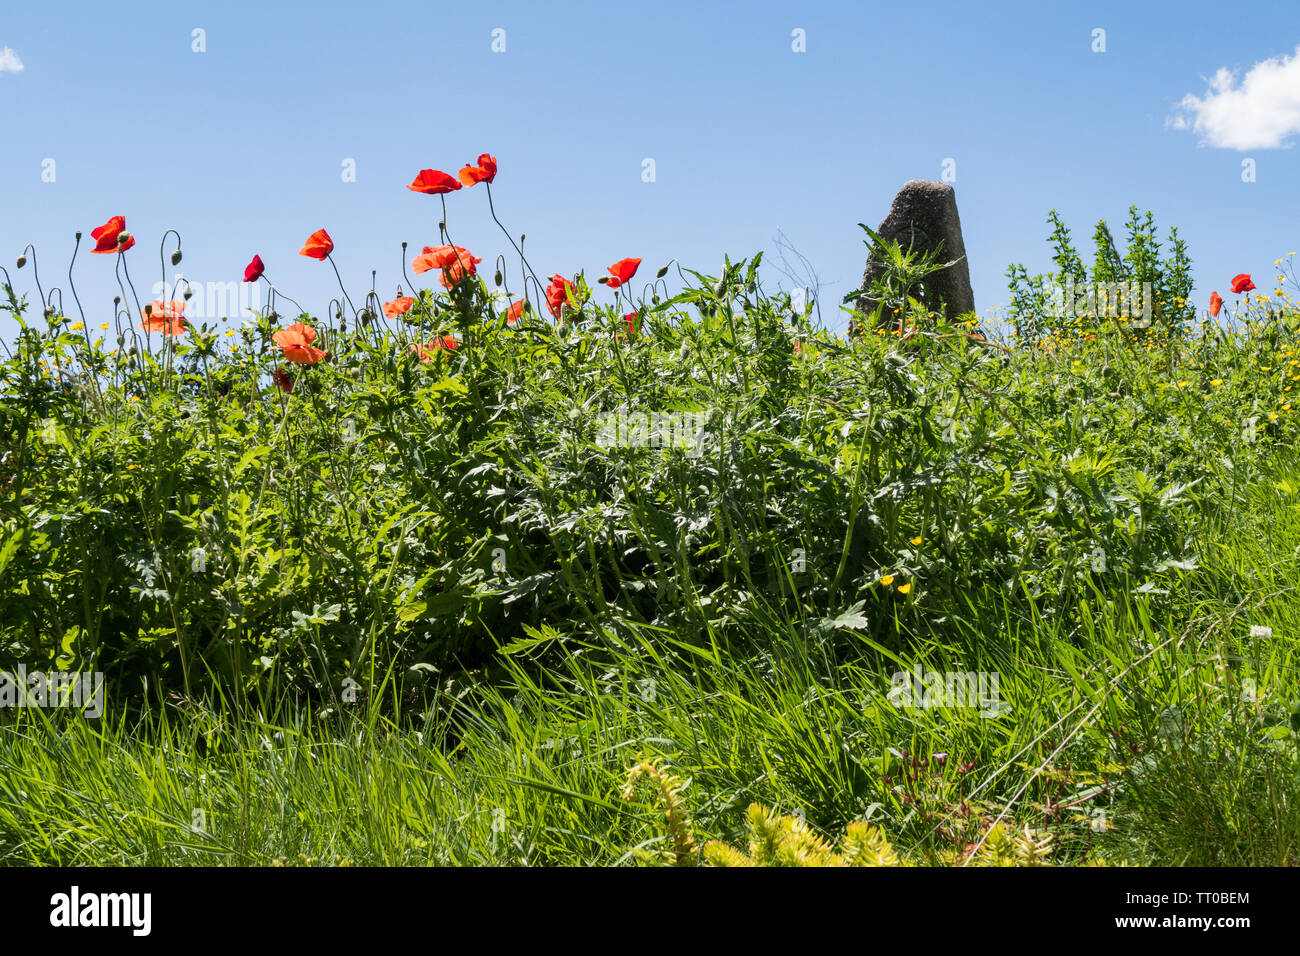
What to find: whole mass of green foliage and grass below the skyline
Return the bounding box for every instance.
[0,231,1300,865]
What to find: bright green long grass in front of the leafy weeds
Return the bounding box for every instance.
[0,447,1300,865]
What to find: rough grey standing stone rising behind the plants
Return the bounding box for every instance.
[857,179,975,335]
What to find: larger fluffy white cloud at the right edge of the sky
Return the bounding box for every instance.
[1166,47,1300,150]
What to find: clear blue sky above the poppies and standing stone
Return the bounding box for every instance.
[0,0,1300,336]
